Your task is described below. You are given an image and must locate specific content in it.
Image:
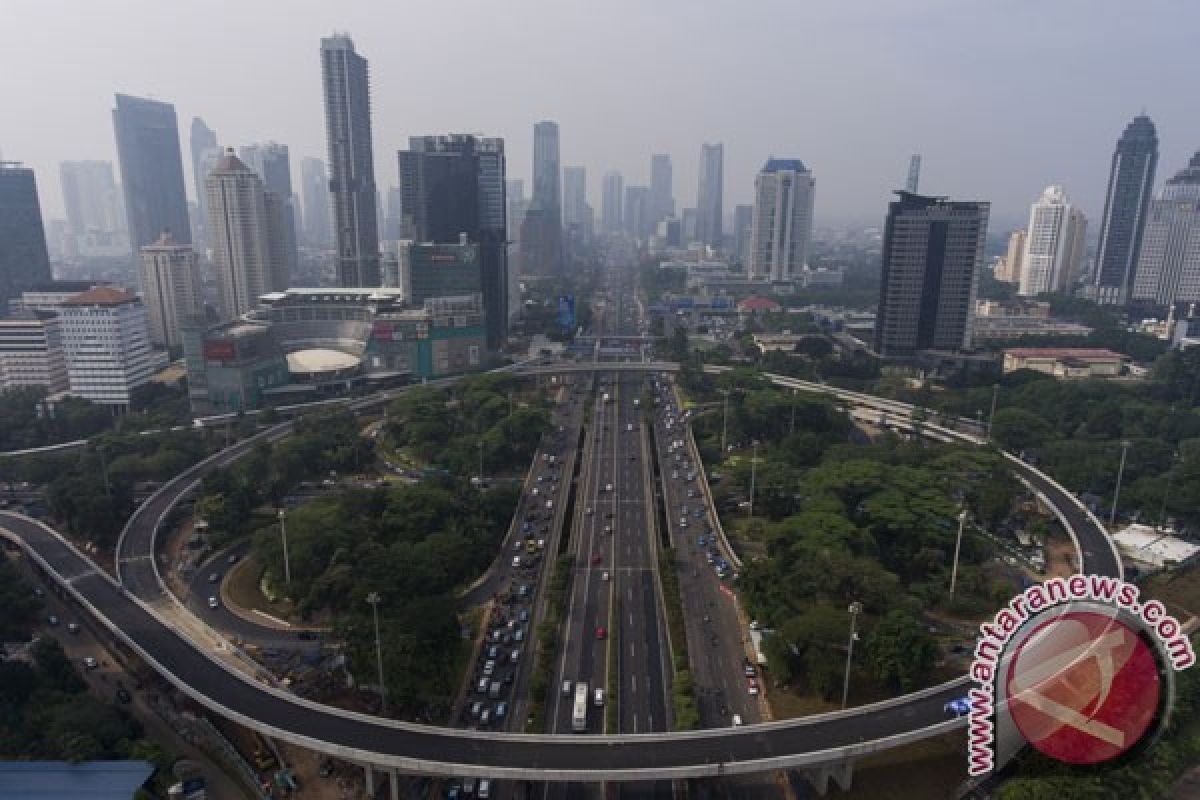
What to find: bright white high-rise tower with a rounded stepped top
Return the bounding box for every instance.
[1018,186,1087,297]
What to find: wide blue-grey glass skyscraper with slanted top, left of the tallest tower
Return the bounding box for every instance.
[113,95,192,252]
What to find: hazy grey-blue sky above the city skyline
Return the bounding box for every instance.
[0,0,1200,233]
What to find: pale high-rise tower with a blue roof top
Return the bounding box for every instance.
[748,158,815,281]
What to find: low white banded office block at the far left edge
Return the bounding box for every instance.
[0,311,68,395]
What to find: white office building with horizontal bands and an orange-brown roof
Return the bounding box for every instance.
[59,287,167,407]
